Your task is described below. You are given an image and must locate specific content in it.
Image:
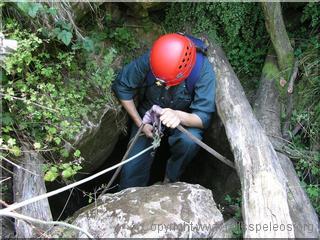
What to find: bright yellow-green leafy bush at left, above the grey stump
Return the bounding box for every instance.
[0,19,116,181]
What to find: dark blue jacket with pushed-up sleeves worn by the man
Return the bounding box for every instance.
[112,51,215,128]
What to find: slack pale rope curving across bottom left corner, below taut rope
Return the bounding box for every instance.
[0,212,94,239]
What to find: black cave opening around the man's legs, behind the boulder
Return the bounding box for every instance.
[47,114,240,220]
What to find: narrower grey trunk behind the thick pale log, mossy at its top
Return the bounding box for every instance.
[254,51,320,238]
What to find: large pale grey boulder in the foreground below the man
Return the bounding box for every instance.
[55,182,223,238]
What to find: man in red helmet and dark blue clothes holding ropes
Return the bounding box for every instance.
[113,33,215,189]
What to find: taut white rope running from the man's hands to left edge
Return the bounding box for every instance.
[0,145,154,215]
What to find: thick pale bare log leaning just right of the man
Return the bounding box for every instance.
[209,41,294,238]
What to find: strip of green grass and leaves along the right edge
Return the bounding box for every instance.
[290,18,320,215]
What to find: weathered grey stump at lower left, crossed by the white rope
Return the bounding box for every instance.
[13,144,52,238]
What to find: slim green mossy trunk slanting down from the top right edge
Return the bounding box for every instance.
[261,1,294,81]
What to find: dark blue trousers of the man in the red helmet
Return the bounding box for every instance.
[120,124,203,189]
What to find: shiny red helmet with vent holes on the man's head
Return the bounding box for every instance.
[150,33,196,86]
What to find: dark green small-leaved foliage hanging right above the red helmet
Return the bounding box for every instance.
[165,2,268,78]
